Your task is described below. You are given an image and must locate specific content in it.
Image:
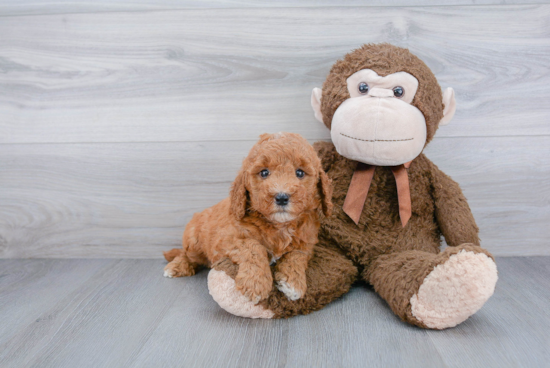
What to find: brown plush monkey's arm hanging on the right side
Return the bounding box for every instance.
[430,162,479,246]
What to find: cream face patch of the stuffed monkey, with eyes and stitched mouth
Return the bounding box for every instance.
[331,69,426,166]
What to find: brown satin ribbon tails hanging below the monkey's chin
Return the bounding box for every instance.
[342,161,412,227]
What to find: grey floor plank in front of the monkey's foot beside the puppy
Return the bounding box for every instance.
[129,263,289,367]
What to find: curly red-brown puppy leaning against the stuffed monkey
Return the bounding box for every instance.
[164,133,332,303]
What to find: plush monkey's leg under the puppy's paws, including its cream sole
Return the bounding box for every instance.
[208,246,357,318]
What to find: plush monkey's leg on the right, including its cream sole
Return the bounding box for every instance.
[365,244,498,329]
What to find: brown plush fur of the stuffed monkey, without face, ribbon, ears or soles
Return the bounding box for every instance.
[212,44,492,327]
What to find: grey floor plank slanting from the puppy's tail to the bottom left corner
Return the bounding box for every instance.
[2,260,186,367]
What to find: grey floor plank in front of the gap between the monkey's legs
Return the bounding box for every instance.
[286,285,444,368]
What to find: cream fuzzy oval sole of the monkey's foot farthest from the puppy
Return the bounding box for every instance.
[410,250,498,329]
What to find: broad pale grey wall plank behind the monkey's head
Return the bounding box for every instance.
[0,5,550,143]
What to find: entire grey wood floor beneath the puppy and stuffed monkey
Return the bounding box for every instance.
[0,257,550,368]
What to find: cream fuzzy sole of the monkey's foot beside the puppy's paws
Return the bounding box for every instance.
[208,268,275,318]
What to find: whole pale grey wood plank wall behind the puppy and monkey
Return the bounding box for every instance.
[0,0,550,258]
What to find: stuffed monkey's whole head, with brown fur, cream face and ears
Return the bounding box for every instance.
[311,43,456,166]
